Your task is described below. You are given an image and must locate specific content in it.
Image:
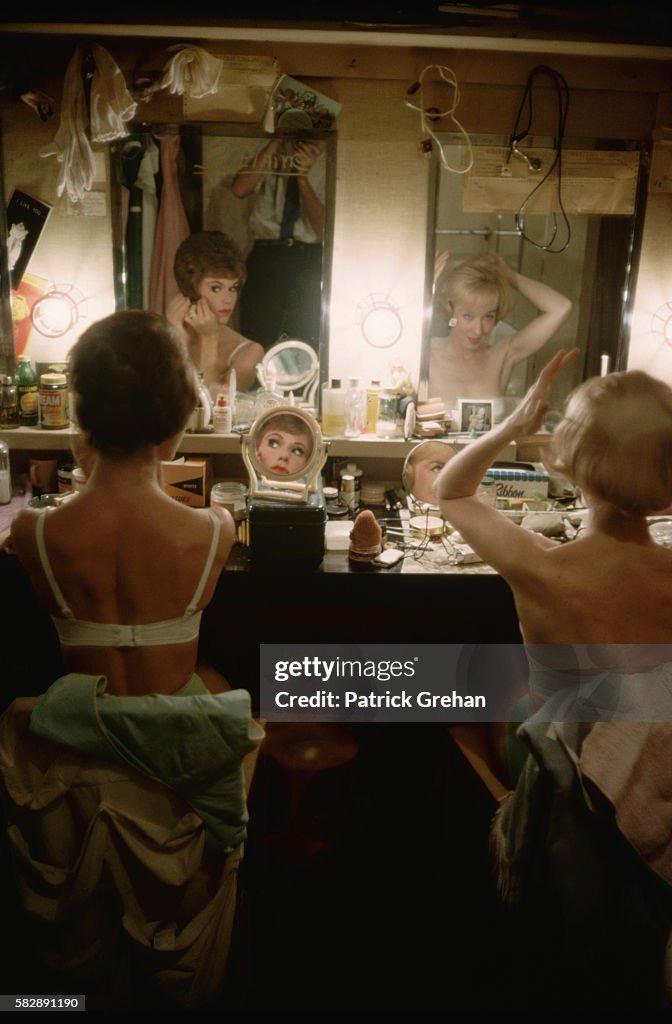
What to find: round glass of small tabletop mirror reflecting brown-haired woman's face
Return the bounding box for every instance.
[248,406,324,482]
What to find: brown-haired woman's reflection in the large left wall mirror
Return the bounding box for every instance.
[167,231,263,391]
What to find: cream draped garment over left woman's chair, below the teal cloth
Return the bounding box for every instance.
[0,697,243,1011]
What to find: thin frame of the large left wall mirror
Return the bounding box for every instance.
[109,119,337,379]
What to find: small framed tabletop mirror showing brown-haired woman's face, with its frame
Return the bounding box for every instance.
[242,406,327,502]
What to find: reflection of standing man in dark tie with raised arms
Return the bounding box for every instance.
[232,137,326,351]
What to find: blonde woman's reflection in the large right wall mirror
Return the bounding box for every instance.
[429,254,572,423]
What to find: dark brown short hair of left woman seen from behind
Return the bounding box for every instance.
[69,309,198,458]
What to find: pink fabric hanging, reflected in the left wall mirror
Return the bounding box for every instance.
[148,135,192,315]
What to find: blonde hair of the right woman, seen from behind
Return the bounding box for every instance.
[544,370,672,515]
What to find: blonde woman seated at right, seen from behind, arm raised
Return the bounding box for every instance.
[435,349,672,797]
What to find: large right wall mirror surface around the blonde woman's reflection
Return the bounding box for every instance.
[419,134,646,415]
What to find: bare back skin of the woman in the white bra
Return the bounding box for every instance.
[11,485,235,695]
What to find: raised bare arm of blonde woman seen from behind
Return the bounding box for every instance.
[434,348,579,580]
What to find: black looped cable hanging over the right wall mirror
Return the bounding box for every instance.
[506,65,572,253]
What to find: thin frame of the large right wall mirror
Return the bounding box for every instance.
[418,132,650,400]
